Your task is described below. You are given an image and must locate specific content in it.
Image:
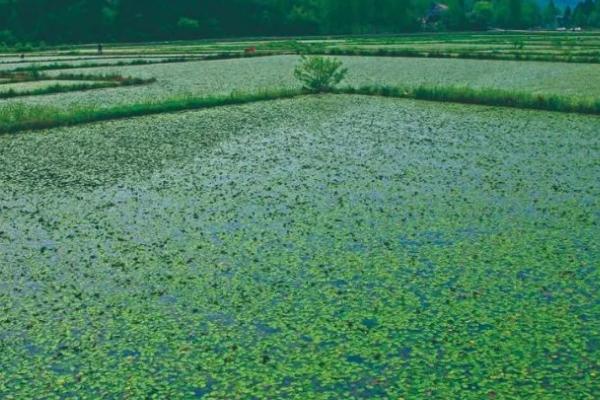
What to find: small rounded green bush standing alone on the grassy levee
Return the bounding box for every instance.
[294,56,348,92]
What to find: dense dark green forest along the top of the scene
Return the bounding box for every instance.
[0,0,600,46]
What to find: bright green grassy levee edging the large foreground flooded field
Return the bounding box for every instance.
[0,86,600,134]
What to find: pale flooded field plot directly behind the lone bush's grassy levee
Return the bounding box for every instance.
[5,56,600,111]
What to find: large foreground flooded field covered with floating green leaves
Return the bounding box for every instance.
[0,95,600,400]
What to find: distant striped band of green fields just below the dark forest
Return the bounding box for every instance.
[2,32,600,65]
